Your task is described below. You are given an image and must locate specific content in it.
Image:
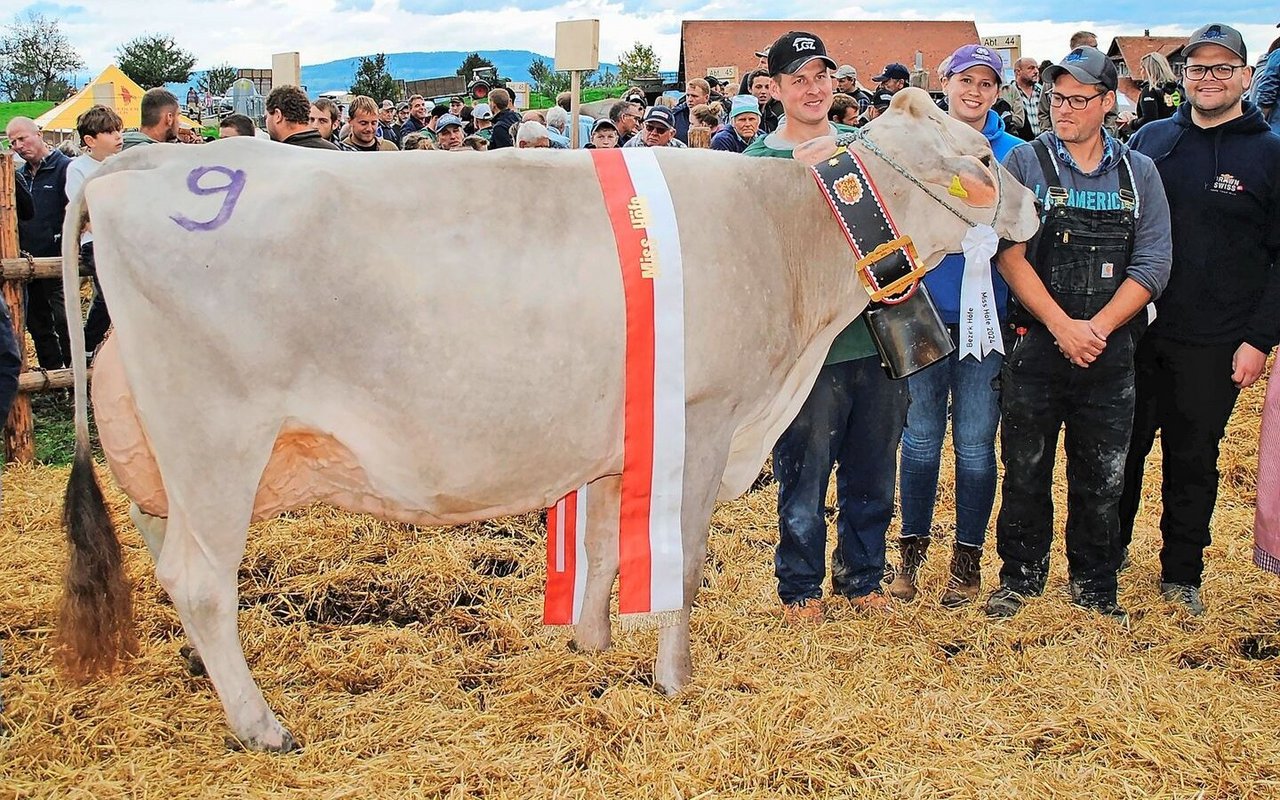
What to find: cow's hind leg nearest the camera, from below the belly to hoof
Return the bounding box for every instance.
[156,498,297,753]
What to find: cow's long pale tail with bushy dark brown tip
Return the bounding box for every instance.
[58,177,138,678]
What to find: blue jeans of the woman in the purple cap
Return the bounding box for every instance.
[901,325,1004,548]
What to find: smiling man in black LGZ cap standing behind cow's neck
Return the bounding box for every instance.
[744,31,906,625]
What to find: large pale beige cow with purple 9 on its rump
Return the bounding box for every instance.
[60,90,1037,751]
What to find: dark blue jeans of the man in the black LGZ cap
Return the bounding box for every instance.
[773,356,906,604]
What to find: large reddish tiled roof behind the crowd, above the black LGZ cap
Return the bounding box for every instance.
[678,19,979,90]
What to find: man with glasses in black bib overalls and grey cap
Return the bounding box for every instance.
[987,46,1171,623]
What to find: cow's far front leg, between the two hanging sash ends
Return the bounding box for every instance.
[573,475,622,650]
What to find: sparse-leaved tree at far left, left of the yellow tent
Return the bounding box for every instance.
[0,12,84,101]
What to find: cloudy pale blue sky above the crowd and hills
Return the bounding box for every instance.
[22,0,1280,74]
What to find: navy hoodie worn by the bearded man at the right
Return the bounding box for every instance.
[1129,102,1280,352]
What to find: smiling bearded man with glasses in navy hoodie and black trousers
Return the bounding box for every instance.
[1120,24,1280,614]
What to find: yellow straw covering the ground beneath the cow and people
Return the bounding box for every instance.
[0,376,1280,800]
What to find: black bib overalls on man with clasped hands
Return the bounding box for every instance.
[996,141,1146,604]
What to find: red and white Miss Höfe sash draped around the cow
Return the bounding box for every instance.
[543,147,685,625]
